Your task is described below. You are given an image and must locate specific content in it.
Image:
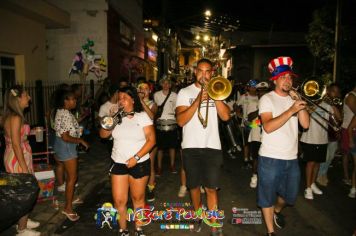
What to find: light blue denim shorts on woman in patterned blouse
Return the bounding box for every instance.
[54,136,78,161]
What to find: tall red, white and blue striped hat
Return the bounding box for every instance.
[268,57,297,80]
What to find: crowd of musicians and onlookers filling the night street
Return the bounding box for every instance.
[3,57,356,236]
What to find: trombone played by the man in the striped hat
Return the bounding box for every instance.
[291,78,340,132]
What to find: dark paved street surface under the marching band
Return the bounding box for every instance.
[1,133,356,236]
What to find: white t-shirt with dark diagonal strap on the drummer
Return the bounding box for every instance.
[153,90,177,120]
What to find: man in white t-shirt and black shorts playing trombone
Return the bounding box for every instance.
[176,58,231,235]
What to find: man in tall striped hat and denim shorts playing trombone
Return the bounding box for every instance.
[257,57,309,235]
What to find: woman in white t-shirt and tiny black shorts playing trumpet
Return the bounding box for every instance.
[99,87,156,235]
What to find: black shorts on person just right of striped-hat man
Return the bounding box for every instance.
[301,142,328,163]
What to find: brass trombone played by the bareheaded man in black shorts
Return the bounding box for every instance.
[198,76,232,129]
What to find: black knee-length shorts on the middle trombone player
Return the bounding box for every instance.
[182,148,223,189]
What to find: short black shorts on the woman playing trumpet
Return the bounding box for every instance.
[109,159,151,179]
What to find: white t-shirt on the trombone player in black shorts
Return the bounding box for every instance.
[177,84,221,150]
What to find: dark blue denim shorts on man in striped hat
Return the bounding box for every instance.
[257,156,300,208]
